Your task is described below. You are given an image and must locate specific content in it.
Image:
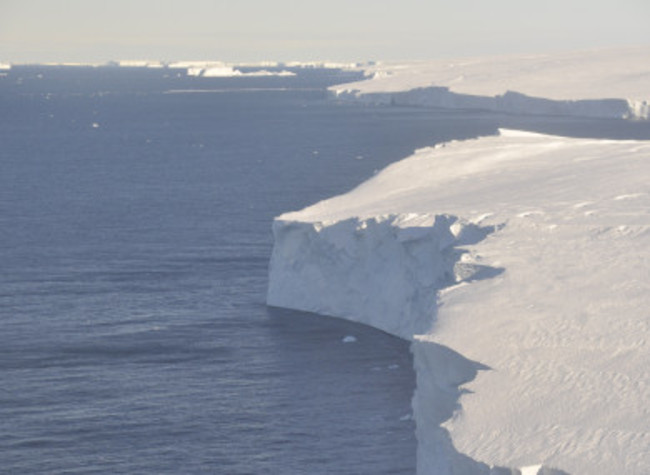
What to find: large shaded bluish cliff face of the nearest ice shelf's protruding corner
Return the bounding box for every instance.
[267,214,493,339]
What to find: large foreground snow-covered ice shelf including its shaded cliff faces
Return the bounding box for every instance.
[268,131,650,475]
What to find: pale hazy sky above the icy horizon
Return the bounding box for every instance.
[0,0,650,62]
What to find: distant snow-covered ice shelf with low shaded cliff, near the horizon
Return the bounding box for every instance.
[331,47,650,119]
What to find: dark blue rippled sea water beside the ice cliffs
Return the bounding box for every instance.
[0,67,647,474]
